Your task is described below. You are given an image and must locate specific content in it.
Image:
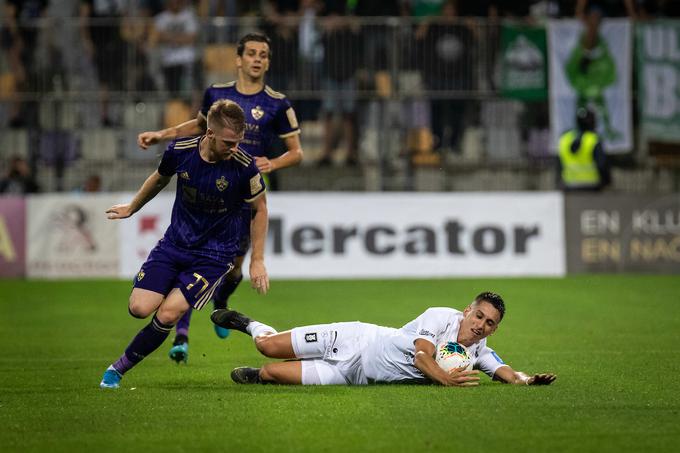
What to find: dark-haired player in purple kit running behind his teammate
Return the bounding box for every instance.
[137,33,302,363]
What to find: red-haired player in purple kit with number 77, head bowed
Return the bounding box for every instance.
[100,100,269,388]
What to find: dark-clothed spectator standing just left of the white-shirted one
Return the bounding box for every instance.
[80,0,125,126]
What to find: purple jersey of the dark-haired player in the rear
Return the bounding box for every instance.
[201,82,300,157]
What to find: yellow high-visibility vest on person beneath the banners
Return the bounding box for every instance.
[559,130,600,187]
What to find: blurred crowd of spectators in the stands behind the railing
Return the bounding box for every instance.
[0,0,680,192]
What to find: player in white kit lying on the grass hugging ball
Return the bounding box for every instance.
[211,292,556,387]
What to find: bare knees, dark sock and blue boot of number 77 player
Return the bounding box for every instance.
[100,288,189,388]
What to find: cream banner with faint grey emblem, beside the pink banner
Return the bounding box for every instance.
[26,194,119,278]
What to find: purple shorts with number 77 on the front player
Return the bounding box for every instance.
[133,239,234,310]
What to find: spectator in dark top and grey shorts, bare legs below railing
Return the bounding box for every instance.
[319,2,362,166]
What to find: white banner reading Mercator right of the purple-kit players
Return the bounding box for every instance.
[244,192,566,279]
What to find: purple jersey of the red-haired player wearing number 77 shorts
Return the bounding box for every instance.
[158,136,265,263]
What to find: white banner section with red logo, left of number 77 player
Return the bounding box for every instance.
[117,192,175,278]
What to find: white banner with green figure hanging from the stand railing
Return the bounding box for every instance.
[548,19,633,153]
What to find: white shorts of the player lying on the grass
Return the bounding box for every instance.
[291,322,378,385]
